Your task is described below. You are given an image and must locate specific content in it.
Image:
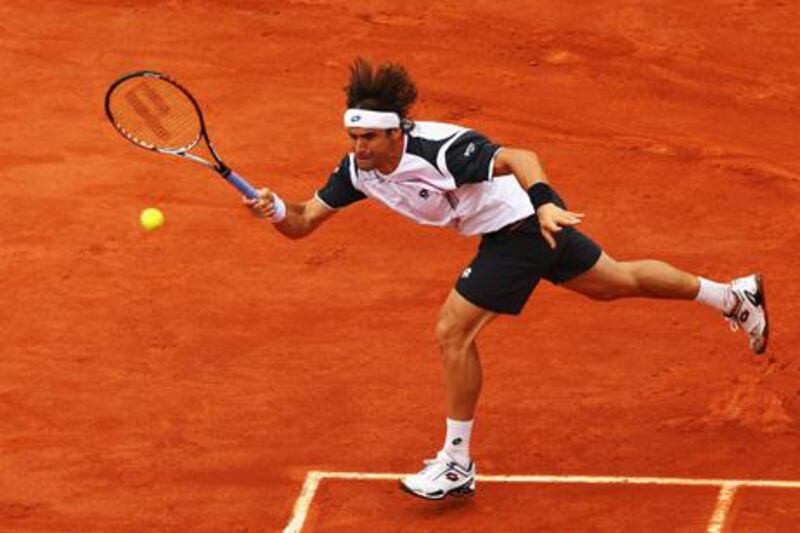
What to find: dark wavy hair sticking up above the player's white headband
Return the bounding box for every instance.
[344,57,417,129]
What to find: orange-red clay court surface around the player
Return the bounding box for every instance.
[0,0,800,532]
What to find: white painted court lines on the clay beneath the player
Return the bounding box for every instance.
[283,471,800,533]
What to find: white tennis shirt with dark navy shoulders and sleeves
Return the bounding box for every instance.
[316,122,534,235]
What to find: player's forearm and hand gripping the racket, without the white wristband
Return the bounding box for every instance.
[244,188,336,239]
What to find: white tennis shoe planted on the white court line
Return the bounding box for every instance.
[400,451,476,500]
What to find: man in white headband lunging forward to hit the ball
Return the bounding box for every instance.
[244,59,769,499]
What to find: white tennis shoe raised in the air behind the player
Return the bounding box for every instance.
[724,274,769,354]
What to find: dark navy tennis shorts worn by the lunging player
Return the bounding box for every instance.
[456,205,603,315]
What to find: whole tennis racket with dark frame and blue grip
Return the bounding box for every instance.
[106,70,258,198]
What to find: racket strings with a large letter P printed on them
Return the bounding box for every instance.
[109,77,202,151]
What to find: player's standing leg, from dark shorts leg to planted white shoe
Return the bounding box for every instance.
[401,217,558,499]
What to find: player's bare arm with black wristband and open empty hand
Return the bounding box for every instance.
[492,148,584,248]
